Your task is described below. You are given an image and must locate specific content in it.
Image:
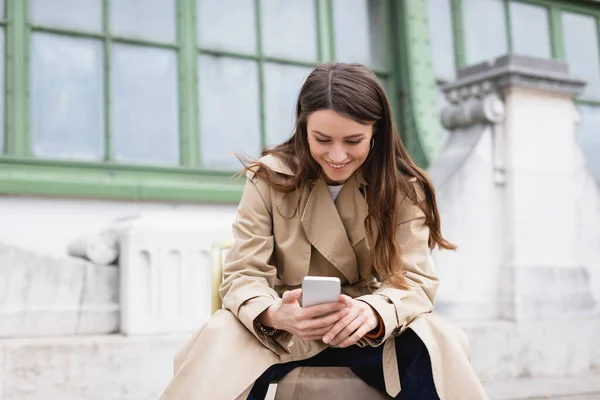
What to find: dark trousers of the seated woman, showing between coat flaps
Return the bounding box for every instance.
[248,329,439,400]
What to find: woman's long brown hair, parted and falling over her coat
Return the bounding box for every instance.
[241,63,456,288]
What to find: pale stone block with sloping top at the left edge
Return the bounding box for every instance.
[0,243,120,337]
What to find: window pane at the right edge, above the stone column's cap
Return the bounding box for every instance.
[562,13,600,98]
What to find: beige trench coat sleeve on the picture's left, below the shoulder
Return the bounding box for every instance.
[219,174,282,353]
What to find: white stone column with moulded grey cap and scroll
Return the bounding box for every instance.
[430,55,597,321]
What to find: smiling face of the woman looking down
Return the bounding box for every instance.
[306,110,373,185]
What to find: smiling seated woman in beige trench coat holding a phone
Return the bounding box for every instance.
[162,64,487,400]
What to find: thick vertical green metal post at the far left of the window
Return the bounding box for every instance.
[5,0,30,157]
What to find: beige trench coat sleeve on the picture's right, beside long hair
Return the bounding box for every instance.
[357,185,439,346]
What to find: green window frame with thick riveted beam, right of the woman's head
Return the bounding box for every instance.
[398,0,600,167]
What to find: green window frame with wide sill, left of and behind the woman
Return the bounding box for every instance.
[0,0,397,203]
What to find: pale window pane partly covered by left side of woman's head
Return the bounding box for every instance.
[265,63,312,146]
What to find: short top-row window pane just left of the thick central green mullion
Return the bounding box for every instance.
[110,0,176,42]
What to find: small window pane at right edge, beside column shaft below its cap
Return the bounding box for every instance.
[577,104,600,181]
